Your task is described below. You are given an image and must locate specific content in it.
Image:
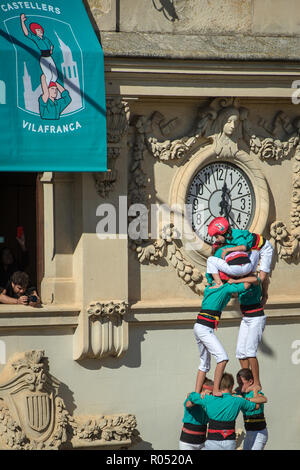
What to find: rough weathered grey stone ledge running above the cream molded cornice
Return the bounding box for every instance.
[101,32,300,62]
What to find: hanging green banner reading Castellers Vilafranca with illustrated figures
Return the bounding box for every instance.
[0,0,107,172]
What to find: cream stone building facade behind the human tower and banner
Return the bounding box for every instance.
[0,0,300,450]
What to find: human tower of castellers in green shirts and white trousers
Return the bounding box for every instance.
[179,217,273,450]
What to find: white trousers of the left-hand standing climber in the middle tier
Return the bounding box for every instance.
[194,323,228,373]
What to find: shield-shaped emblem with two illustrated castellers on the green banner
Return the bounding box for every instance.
[5,13,84,121]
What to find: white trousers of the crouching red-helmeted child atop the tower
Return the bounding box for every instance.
[206,250,259,277]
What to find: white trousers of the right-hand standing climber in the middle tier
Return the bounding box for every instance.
[236,315,267,359]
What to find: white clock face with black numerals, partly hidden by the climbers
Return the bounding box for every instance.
[186,162,255,243]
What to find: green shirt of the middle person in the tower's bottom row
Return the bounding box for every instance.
[189,392,256,421]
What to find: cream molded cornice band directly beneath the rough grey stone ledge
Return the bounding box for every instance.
[105,56,299,100]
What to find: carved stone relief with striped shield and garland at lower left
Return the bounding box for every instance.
[0,350,138,450]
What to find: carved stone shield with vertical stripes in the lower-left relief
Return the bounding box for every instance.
[26,393,51,432]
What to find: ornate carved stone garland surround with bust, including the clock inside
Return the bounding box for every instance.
[128,98,300,295]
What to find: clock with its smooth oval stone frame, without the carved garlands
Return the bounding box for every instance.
[169,144,270,260]
